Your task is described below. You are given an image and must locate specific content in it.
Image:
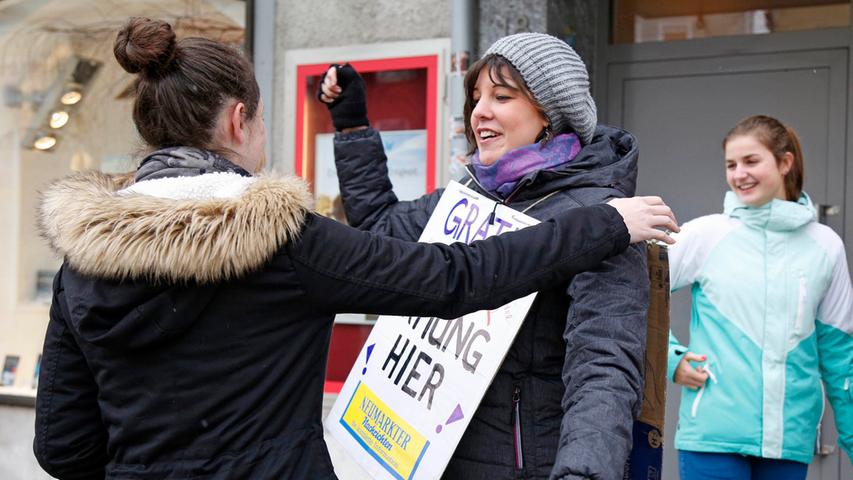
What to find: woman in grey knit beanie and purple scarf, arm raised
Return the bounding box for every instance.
[318,33,649,480]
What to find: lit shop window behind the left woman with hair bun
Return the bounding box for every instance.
[0,0,246,395]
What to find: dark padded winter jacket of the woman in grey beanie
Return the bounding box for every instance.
[335,126,649,480]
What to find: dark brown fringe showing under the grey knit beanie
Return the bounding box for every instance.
[463,53,545,155]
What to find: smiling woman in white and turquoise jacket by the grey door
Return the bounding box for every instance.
[668,116,853,480]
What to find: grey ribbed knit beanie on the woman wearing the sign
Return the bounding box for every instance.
[486,33,597,144]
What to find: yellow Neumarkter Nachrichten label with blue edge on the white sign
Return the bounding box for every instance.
[341,382,429,480]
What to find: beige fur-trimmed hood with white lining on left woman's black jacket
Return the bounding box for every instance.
[38,172,311,284]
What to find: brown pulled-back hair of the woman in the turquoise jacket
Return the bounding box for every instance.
[723,115,805,202]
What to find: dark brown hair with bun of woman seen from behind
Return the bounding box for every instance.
[113,17,260,150]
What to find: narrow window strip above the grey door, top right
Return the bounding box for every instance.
[611,0,850,43]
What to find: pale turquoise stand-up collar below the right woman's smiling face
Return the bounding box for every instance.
[723,191,817,232]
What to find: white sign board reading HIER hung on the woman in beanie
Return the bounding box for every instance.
[326,182,538,480]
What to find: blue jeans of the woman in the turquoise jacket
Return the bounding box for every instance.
[678,450,809,480]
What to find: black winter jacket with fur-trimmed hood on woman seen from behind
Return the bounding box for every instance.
[34,163,628,479]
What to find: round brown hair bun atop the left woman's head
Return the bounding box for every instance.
[113,17,177,75]
